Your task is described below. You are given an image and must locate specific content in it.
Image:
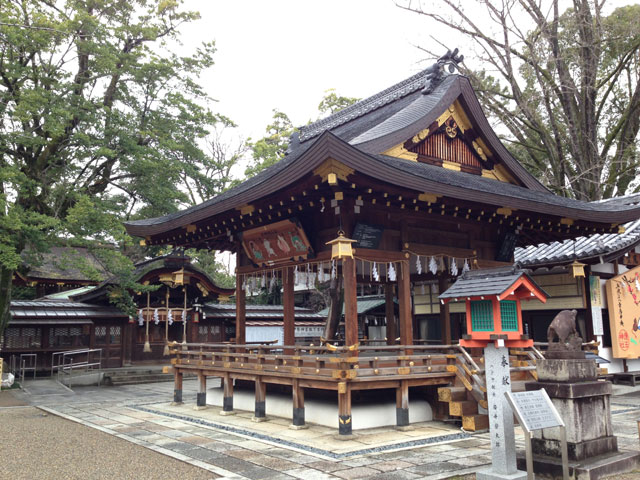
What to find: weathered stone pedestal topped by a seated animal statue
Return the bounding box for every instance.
[518,310,640,479]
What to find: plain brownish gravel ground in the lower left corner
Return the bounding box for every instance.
[0,404,217,480]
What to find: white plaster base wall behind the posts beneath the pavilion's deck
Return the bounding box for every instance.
[207,388,433,430]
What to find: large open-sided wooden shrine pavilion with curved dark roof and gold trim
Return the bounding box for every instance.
[126,52,640,433]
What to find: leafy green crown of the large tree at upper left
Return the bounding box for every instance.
[0,0,237,332]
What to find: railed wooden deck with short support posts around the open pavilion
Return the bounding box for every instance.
[166,344,504,435]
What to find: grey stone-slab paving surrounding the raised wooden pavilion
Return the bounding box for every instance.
[3,380,640,480]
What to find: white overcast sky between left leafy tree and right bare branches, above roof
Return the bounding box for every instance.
[183,0,444,139]
